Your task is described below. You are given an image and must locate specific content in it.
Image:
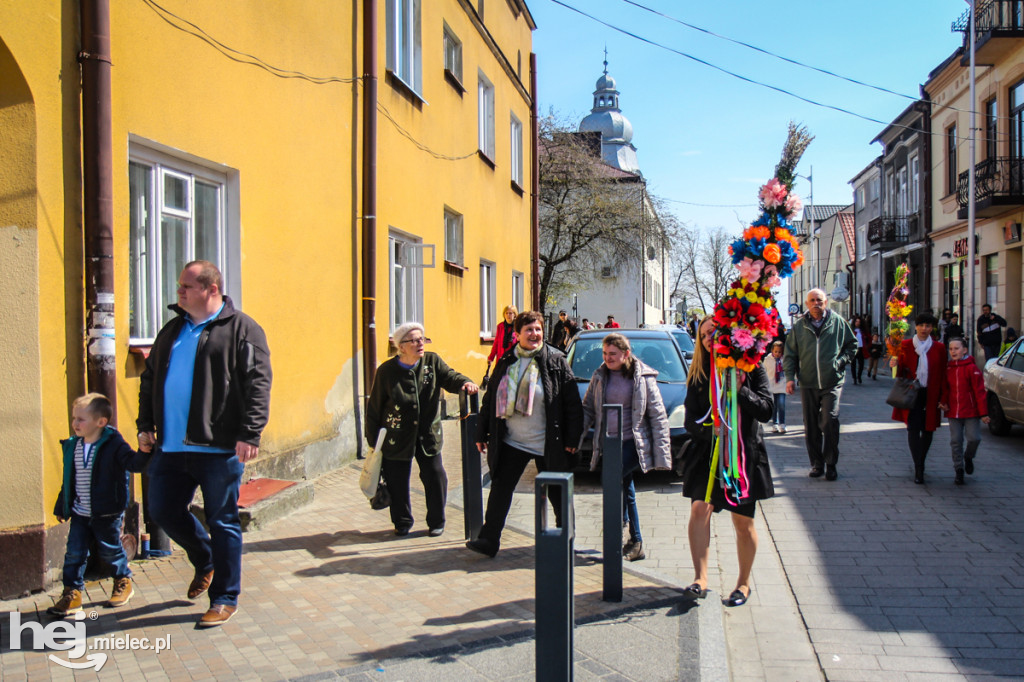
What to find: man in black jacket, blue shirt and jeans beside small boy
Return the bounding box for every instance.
[136,260,271,628]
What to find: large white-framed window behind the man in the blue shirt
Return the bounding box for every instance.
[128,145,241,343]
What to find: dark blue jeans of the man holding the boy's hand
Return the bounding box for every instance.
[148,450,246,606]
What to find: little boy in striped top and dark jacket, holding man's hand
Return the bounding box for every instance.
[46,393,152,617]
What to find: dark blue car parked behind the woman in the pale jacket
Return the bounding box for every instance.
[567,329,689,467]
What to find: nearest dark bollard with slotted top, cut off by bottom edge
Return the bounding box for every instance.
[534,471,575,682]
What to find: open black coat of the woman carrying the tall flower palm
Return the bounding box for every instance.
[683,366,775,502]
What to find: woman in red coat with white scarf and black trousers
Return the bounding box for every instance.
[889,312,946,484]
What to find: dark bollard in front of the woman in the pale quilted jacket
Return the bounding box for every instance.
[594,404,623,601]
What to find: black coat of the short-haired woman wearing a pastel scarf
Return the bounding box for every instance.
[476,344,583,471]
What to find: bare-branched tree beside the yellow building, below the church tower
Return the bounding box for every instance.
[539,116,665,312]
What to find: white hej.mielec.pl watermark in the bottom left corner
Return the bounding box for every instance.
[8,611,171,672]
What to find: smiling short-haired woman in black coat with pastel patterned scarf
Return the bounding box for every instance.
[466,311,583,557]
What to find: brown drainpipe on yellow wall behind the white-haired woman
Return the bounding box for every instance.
[362,0,377,400]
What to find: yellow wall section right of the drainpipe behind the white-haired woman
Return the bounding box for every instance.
[377,0,531,381]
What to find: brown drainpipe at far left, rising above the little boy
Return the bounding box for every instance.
[78,0,118,425]
